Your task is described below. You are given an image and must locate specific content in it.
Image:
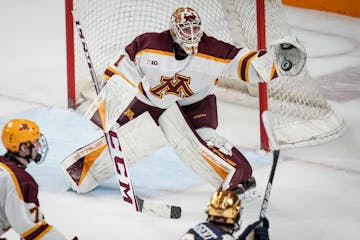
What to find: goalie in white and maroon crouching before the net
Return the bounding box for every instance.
[61,7,306,198]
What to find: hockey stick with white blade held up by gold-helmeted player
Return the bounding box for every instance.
[260,111,280,219]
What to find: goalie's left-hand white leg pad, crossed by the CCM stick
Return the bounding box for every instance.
[60,112,167,193]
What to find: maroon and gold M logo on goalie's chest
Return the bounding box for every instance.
[150,74,194,98]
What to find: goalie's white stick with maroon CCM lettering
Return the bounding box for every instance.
[72,11,181,218]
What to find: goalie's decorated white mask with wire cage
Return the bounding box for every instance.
[170,7,203,54]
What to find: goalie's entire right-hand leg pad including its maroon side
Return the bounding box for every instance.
[159,104,252,188]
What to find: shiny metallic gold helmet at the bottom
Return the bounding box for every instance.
[207,190,241,225]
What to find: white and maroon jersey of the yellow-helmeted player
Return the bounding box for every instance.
[0,156,73,240]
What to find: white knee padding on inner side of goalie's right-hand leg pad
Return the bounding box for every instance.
[196,127,234,156]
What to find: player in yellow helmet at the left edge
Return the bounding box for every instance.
[0,119,77,240]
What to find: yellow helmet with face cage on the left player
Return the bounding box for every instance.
[1,119,48,164]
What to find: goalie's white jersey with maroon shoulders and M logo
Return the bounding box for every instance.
[105,30,276,109]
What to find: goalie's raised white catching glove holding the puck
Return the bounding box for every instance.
[271,36,307,76]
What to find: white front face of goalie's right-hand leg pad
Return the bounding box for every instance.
[159,104,234,188]
